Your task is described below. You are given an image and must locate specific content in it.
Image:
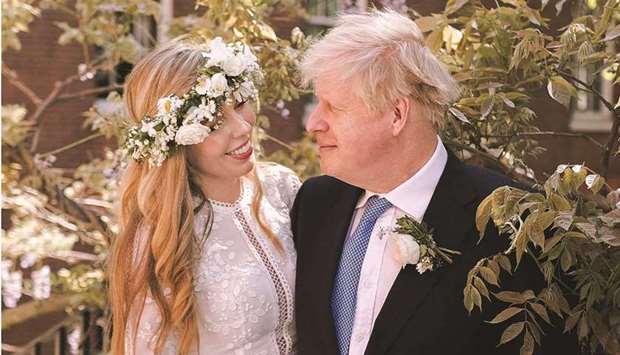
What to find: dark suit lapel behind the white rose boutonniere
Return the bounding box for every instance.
[366,151,475,354]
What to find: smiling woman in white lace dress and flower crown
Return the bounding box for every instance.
[107,38,300,355]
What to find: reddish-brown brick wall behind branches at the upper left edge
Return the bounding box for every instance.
[2,7,109,167]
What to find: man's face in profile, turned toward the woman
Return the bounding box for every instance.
[306,77,392,187]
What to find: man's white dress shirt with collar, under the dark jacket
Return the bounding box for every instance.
[347,136,448,355]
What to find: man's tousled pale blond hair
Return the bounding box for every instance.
[301,10,458,127]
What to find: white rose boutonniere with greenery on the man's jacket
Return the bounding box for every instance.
[392,216,461,274]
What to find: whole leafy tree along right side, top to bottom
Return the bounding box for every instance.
[412,0,620,354]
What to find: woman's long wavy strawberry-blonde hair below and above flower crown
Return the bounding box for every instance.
[107,38,282,355]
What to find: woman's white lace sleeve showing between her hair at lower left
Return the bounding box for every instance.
[125,227,176,355]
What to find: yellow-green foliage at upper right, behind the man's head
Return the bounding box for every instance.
[416,0,620,182]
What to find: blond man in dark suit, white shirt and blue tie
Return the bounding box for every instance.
[291,11,577,355]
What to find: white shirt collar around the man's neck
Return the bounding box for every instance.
[355,136,448,218]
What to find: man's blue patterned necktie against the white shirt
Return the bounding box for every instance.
[331,196,392,355]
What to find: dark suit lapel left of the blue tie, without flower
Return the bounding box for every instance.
[307,183,362,354]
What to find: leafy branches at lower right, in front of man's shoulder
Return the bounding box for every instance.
[464,165,620,354]
